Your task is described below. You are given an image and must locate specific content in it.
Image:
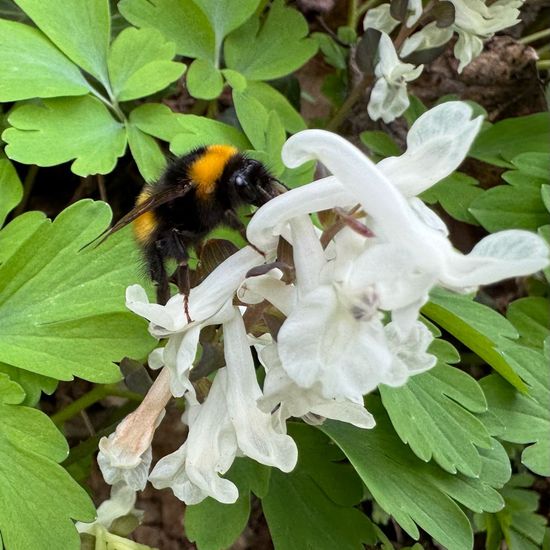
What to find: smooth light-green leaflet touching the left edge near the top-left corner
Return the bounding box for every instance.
[0,19,90,101]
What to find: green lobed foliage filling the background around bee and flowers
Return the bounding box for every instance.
[0,0,550,550]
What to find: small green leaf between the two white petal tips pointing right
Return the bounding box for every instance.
[420,172,483,225]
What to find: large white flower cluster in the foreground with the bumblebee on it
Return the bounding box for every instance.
[99,102,549,504]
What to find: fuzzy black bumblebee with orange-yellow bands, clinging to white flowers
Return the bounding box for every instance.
[100,145,286,321]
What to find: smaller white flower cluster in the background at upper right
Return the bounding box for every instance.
[363,0,523,122]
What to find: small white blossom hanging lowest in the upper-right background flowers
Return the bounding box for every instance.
[367,32,423,122]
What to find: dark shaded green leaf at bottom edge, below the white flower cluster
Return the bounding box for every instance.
[262,424,372,550]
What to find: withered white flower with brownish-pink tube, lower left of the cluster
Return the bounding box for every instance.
[97,370,171,491]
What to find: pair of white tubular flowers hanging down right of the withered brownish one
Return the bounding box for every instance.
[150,308,297,504]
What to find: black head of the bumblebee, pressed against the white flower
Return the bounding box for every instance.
[229,157,287,206]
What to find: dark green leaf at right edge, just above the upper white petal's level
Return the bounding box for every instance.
[469,113,550,168]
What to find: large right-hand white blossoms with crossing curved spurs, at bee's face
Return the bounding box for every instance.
[247,102,548,404]
